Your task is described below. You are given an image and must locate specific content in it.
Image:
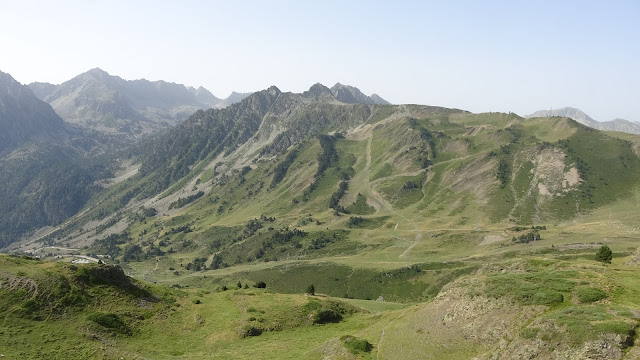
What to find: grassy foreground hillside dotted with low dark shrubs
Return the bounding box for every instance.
[0,218,640,359]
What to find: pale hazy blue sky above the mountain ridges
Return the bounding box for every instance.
[0,0,640,121]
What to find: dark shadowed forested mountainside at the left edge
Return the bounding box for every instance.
[0,73,122,247]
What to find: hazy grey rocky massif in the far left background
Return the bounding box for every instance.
[29,68,221,137]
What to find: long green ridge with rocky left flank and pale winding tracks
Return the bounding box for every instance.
[25,94,640,252]
